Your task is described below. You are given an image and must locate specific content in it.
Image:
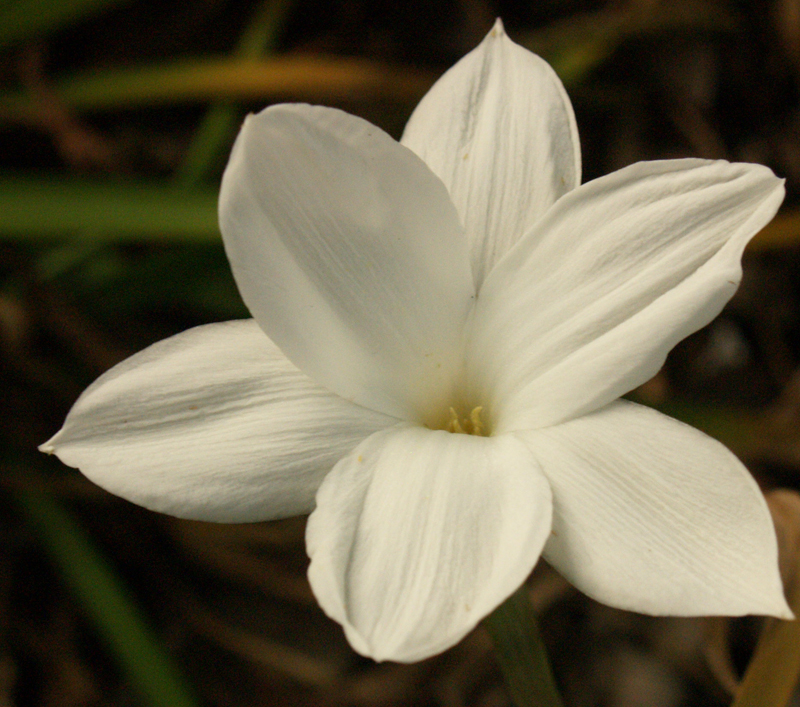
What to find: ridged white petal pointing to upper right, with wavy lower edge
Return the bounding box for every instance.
[471,160,783,430]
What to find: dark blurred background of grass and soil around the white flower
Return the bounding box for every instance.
[0,0,800,707]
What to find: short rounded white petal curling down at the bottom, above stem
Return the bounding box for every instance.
[306,426,551,662]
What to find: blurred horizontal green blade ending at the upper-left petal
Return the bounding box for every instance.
[0,176,220,242]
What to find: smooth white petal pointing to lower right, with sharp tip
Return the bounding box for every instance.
[517,401,791,618]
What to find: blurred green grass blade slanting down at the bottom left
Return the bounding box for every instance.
[17,491,198,707]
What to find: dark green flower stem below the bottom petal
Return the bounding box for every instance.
[483,584,563,707]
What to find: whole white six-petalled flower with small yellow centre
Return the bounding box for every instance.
[42,22,791,661]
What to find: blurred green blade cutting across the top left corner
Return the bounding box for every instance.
[0,0,130,47]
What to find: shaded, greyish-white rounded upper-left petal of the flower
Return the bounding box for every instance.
[220,105,474,419]
